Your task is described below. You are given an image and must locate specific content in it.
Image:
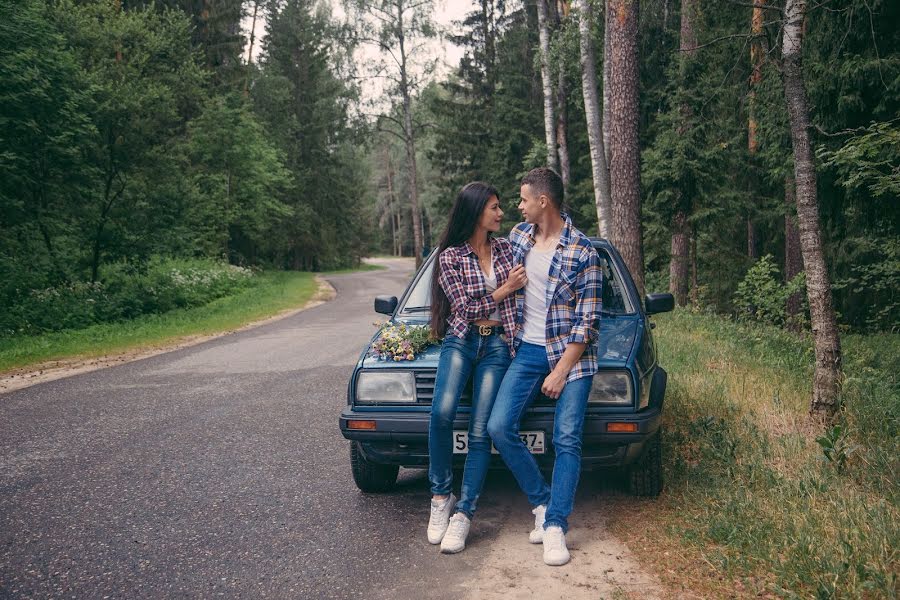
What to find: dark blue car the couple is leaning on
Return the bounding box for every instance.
[339,238,674,496]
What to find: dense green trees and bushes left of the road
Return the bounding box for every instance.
[0,0,371,331]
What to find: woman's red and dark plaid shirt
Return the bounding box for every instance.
[438,238,516,353]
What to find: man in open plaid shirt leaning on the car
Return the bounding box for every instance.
[488,168,602,566]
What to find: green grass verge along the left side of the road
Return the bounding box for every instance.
[0,271,318,372]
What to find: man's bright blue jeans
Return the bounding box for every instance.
[488,342,594,531]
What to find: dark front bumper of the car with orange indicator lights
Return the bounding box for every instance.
[340,407,661,468]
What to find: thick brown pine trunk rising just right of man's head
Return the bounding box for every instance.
[608,0,644,297]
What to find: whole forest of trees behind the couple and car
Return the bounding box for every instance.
[0,0,900,410]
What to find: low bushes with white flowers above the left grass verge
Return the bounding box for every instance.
[0,257,253,336]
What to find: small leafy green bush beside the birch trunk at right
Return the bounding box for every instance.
[734,254,806,326]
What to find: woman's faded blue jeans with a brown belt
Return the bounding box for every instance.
[428,326,510,519]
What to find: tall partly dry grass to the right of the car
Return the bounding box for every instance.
[610,311,900,598]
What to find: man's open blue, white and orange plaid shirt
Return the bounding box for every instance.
[509,213,603,381]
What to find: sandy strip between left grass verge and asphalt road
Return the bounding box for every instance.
[0,275,337,396]
